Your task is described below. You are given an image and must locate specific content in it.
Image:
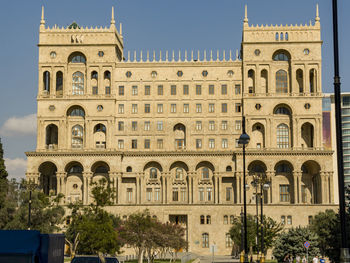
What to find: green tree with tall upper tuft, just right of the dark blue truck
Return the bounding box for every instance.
[65,179,121,255]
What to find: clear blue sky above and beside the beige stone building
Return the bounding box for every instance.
[0,0,350,177]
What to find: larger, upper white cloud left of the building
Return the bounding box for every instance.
[0,114,36,137]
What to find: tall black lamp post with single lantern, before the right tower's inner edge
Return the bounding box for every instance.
[238,116,250,263]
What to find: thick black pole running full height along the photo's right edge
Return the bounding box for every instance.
[332,0,350,263]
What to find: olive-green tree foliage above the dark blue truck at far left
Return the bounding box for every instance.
[4,181,65,233]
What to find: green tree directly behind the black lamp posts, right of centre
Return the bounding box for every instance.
[229,215,283,252]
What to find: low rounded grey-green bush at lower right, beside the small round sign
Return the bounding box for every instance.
[273,227,320,262]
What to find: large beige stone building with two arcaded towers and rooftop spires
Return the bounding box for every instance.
[26,5,335,254]
